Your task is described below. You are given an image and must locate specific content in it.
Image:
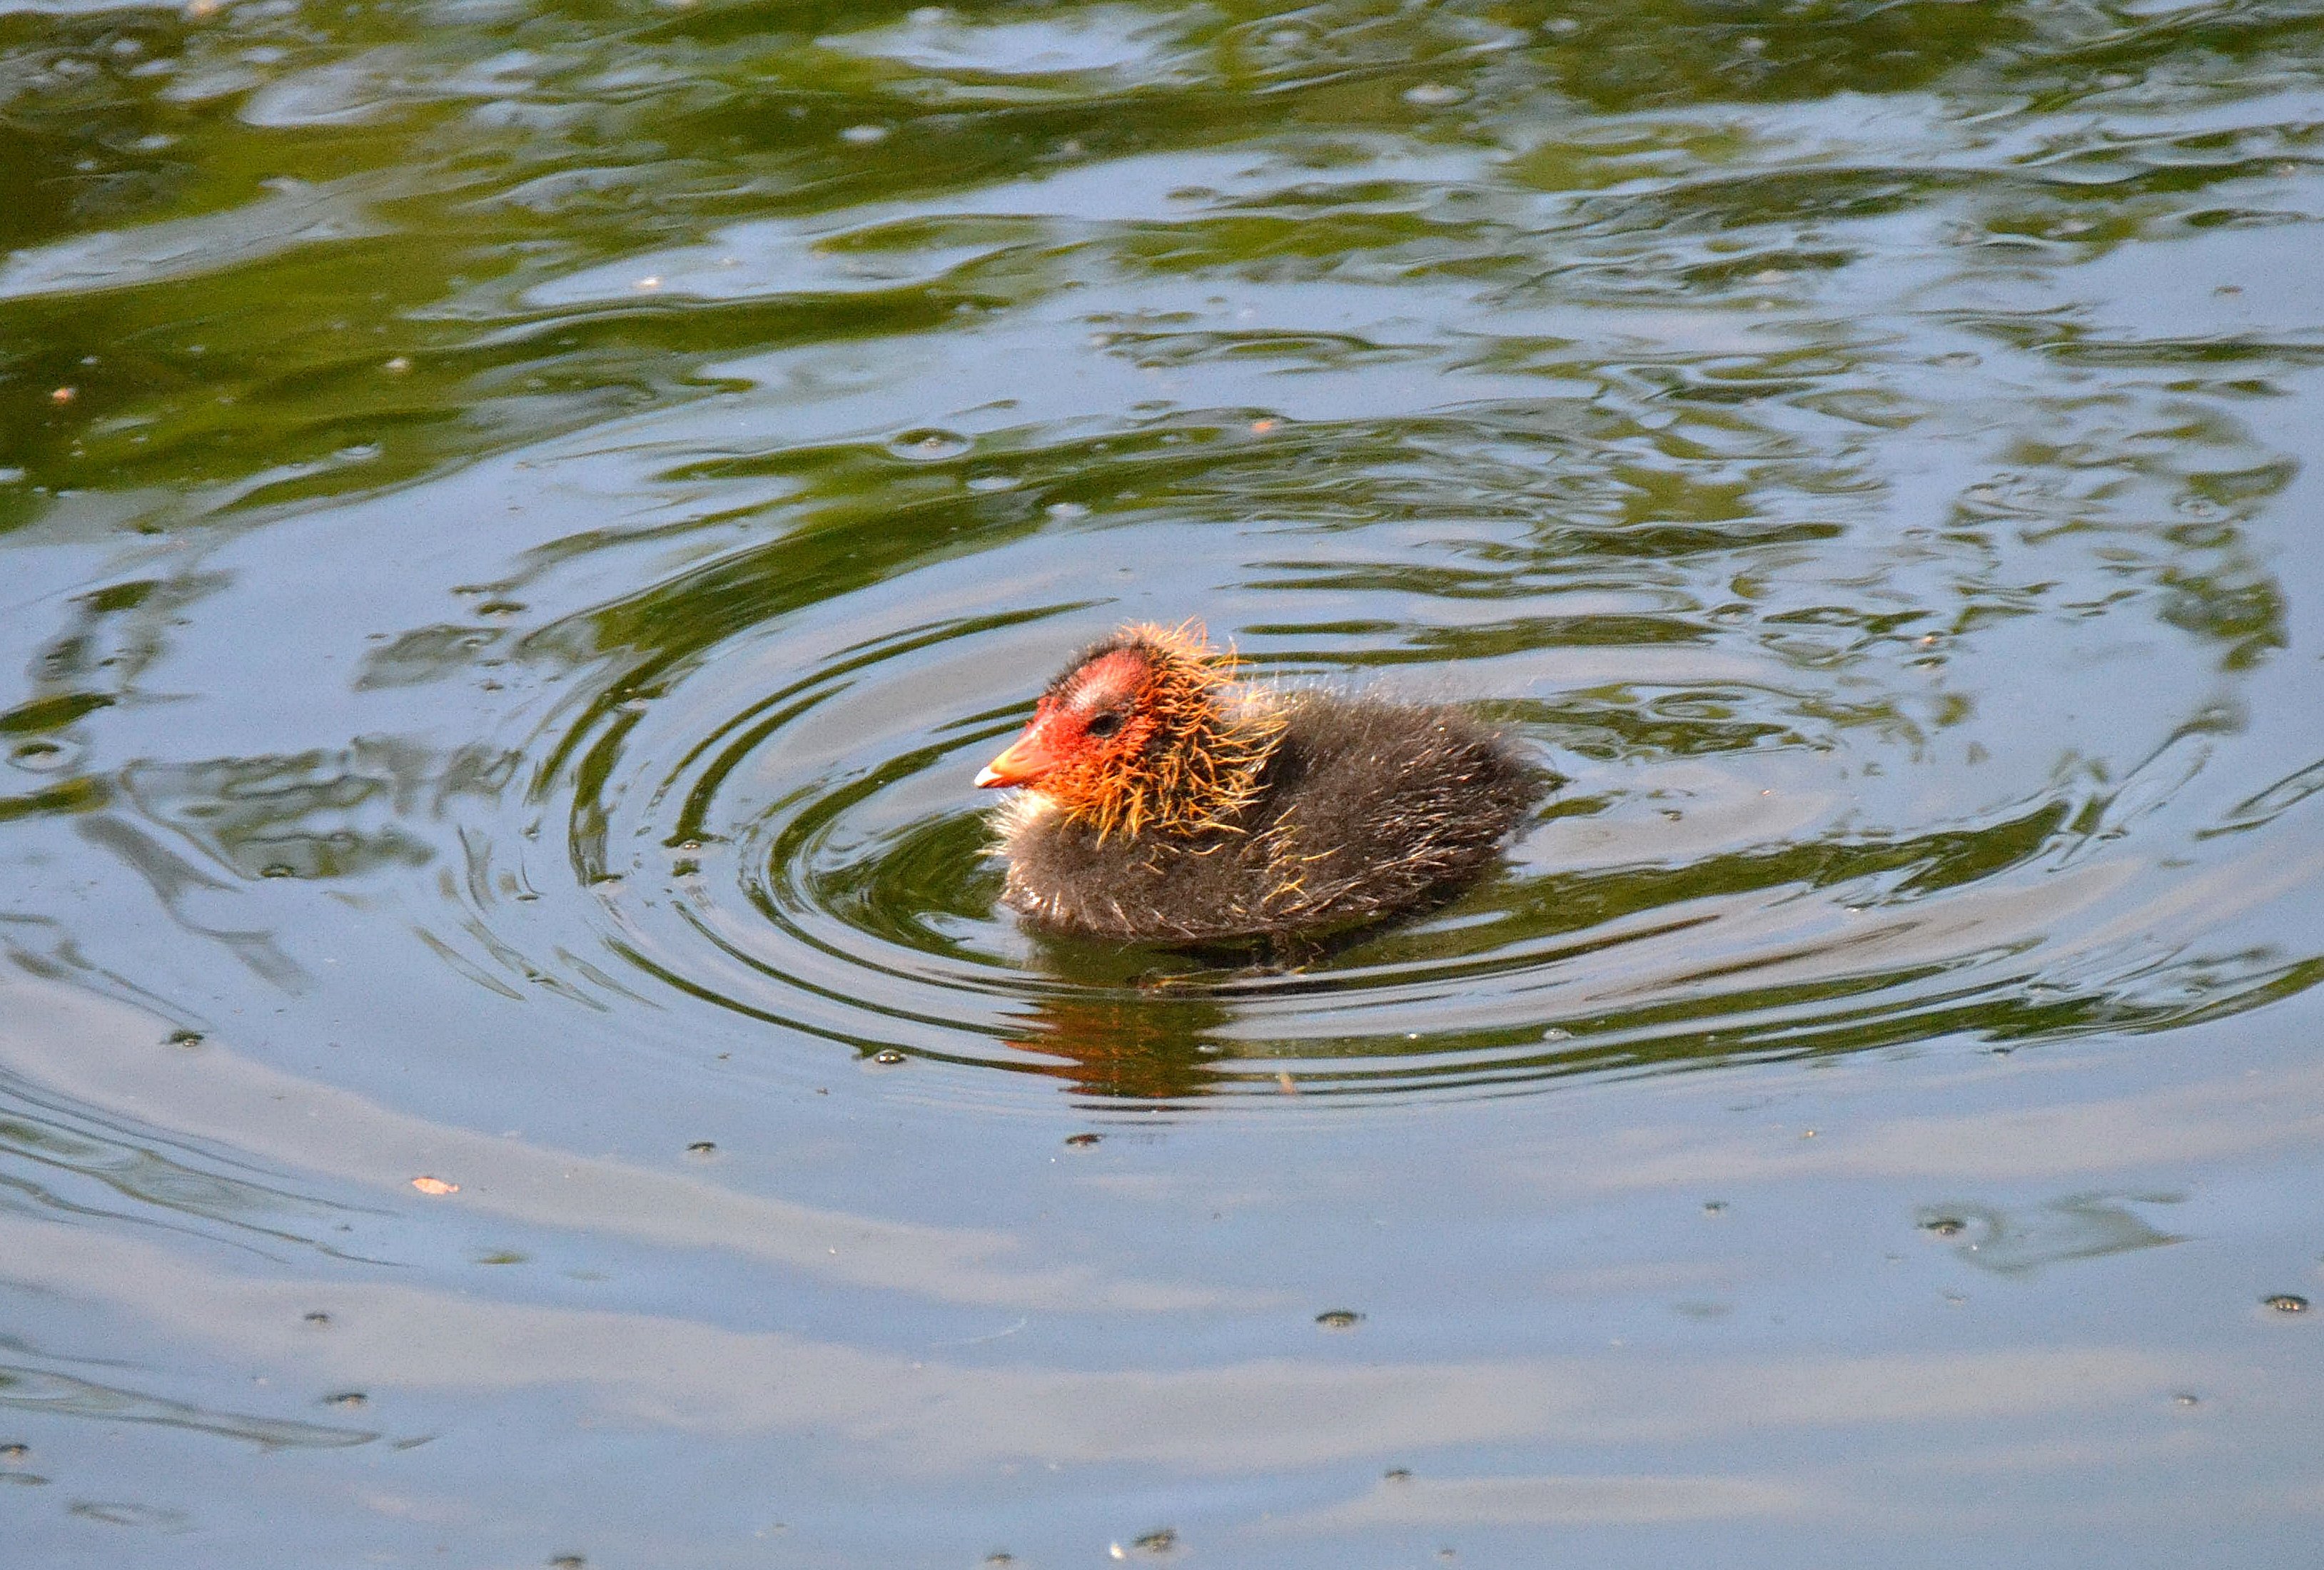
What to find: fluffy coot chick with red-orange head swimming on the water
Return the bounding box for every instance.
[976,627,1550,943]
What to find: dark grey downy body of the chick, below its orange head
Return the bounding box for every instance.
[1001,692,1547,943]
